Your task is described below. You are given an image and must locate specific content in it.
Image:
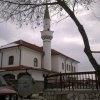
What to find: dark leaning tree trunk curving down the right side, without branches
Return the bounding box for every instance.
[57,0,100,71]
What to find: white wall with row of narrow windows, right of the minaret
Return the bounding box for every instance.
[52,55,78,73]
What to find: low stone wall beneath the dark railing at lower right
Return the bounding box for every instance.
[44,90,100,100]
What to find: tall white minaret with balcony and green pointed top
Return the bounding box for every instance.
[41,5,53,70]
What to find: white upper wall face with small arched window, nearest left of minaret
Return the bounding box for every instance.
[21,47,42,68]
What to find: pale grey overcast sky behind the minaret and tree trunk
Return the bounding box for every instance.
[0,2,100,71]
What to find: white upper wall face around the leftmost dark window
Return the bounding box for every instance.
[1,47,20,67]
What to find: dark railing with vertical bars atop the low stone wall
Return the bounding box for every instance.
[44,71,100,90]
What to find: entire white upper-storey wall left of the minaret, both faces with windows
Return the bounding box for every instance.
[0,47,42,68]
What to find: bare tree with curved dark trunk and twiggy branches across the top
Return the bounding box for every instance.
[0,0,100,70]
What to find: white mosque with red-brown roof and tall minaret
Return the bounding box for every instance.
[0,7,79,92]
